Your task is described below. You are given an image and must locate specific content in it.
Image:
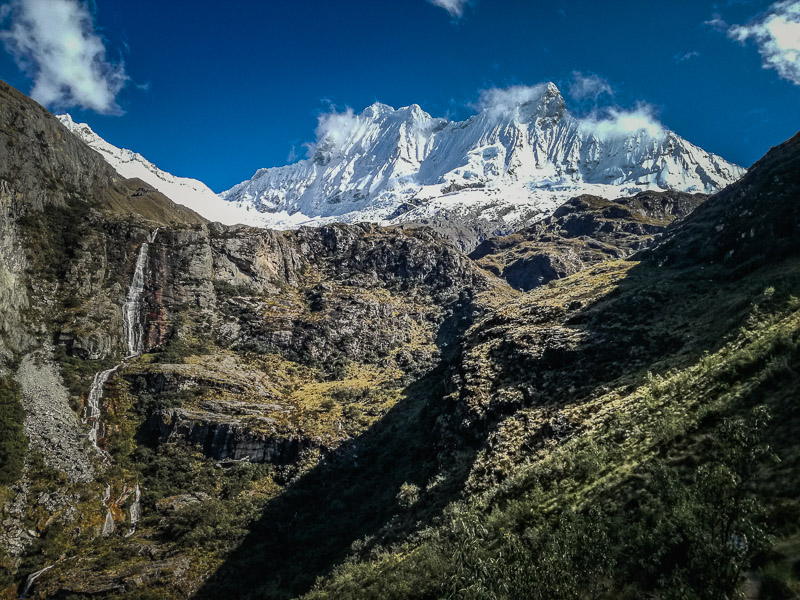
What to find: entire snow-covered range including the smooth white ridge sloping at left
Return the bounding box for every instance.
[60,83,745,247]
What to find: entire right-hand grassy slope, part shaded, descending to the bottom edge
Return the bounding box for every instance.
[296,136,800,600]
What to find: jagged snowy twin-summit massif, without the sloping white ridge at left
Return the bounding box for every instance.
[221,83,744,230]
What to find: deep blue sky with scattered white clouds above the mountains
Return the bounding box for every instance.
[0,0,800,191]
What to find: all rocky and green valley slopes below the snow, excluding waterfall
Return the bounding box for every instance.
[0,76,800,600]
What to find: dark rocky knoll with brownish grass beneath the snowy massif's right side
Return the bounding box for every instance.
[470,192,707,291]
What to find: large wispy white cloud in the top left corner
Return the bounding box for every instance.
[0,0,128,113]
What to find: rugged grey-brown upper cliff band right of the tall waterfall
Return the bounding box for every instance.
[149,224,485,360]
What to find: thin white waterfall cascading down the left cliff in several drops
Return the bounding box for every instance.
[19,229,158,598]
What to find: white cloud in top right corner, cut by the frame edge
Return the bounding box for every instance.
[728,0,800,85]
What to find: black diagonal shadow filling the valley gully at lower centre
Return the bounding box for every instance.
[196,301,488,598]
